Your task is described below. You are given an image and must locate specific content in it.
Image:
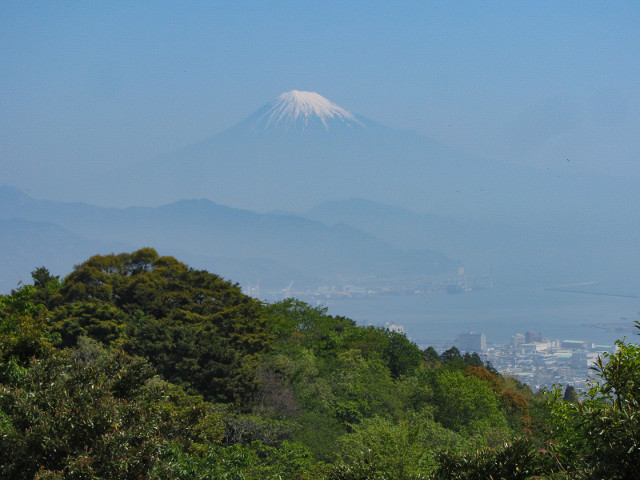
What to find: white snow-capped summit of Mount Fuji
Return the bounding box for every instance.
[258,90,362,130]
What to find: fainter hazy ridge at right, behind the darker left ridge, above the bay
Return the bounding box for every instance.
[300,198,640,293]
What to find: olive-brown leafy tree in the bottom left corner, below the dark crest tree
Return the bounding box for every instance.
[0,338,229,480]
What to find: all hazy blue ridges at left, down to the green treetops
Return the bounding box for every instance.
[0,187,458,290]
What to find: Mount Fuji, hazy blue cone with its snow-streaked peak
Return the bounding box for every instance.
[87,90,627,223]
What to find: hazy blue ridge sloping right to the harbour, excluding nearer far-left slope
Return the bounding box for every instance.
[0,187,457,294]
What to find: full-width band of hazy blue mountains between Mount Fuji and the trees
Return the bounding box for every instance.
[0,182,640,293]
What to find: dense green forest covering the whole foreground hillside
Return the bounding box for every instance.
[0,248,640,480]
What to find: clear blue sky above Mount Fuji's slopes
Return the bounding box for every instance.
[0,0,640,201]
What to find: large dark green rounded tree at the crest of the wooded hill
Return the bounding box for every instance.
[51,248,273,406]
